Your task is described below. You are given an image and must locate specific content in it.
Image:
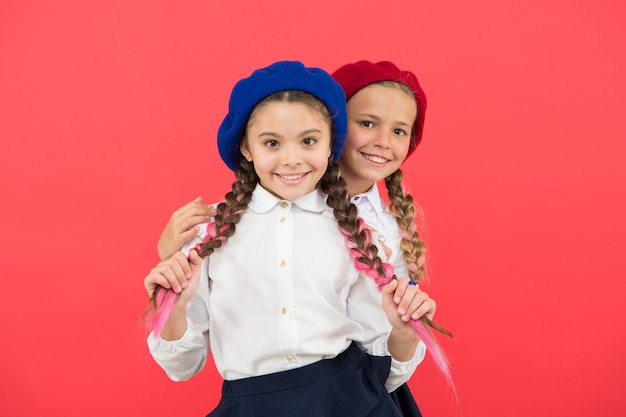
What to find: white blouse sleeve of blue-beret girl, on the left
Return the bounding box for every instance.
[147,254,209,381]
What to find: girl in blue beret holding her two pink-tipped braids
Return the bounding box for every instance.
[144,62,436,417]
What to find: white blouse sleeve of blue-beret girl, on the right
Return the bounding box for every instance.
[347,274,426,392]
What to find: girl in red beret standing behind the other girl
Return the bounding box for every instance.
[157,61,453,417]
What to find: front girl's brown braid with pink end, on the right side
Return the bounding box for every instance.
[320,161,454,389]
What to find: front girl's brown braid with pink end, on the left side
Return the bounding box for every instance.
[145,158,259,337]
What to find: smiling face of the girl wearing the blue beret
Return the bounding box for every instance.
[241,101,331,200]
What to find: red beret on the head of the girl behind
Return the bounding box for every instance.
[332,61,426,158]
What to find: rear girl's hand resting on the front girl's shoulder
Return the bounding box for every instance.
[157,197,216,260]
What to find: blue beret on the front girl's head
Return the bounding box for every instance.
[217,61,348,171]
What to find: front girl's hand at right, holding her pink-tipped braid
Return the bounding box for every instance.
[382,278,437,330]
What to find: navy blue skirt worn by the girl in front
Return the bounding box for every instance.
[207,343,402,417]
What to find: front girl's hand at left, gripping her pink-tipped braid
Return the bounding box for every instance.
[144,250,202,303]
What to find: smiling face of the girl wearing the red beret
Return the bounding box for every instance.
[339,84,417,196]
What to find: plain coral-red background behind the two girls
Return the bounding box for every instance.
[0,0,626,417]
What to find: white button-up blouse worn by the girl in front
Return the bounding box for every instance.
[148,186,425,391]
